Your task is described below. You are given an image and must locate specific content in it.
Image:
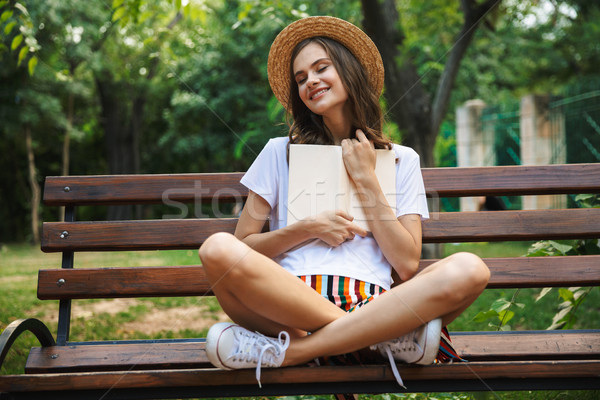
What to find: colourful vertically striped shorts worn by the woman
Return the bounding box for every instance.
[299,275,466,365]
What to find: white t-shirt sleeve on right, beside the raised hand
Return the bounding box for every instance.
[396,148,429,219]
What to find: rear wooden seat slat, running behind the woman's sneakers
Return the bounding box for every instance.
[26,331,600,373]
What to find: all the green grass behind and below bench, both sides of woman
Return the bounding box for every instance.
[0,243,600,400]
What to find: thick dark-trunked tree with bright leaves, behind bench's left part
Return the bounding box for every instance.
[82,1,182,220]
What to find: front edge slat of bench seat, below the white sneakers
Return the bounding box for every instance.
[0,360,600,392]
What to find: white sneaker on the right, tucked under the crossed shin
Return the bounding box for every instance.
[371,318,442,388]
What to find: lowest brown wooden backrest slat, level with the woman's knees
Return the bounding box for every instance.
[38,255,600,300]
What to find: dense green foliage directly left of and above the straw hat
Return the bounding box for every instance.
[148,0,359,172]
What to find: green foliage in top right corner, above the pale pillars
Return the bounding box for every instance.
[448,0,600,120]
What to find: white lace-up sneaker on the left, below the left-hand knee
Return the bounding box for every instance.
[206,322,290,387]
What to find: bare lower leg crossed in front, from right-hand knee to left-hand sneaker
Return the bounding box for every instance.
[283,253,489,366]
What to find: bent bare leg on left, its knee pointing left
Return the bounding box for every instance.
[199,233,346,337]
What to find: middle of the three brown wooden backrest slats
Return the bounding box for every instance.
[42,208,600,252]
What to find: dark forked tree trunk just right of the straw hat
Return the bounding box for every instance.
[362,0,500,167]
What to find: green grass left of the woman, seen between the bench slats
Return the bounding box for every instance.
[0,244,209,374]
